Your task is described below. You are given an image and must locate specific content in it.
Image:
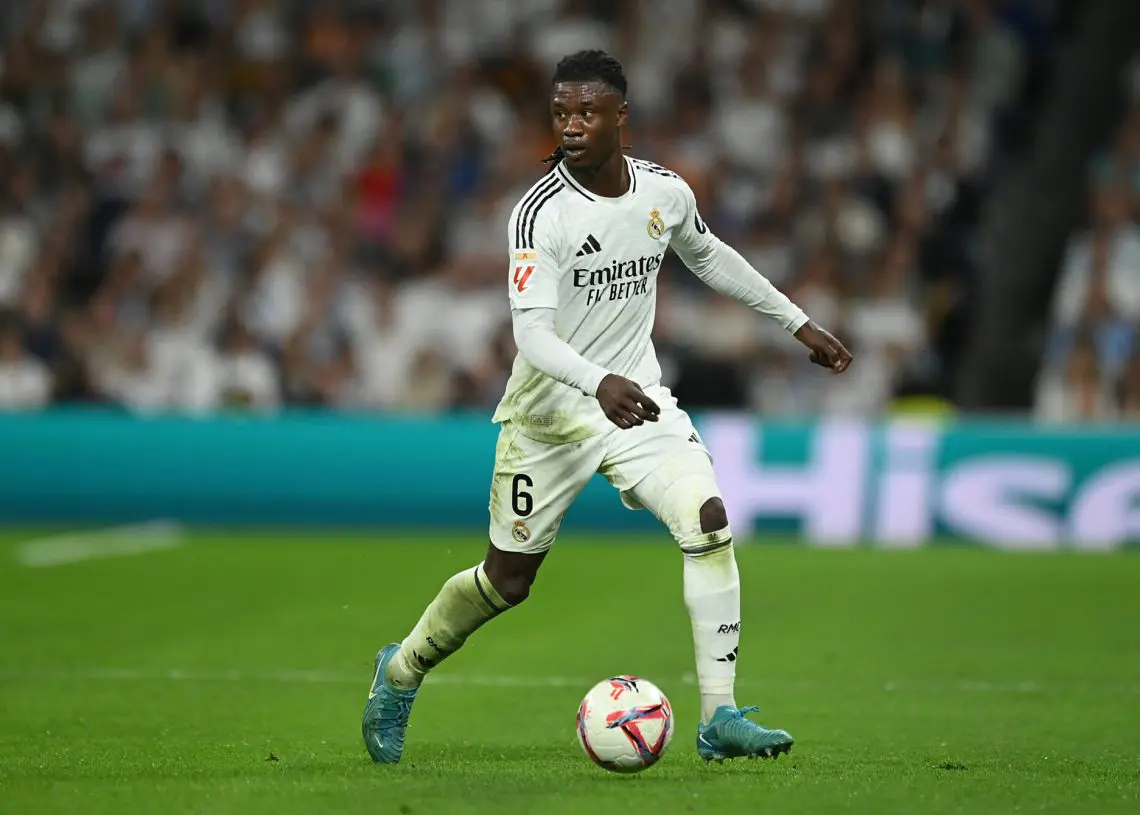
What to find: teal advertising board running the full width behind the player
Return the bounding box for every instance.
[0,410,1140,549]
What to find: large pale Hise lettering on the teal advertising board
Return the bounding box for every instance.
[701,416,1140,549]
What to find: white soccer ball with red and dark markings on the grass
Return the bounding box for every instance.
[578,676,673,773]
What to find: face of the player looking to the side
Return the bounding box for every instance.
[551,82,626,169]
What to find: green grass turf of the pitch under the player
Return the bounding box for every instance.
[0,535,1140,815]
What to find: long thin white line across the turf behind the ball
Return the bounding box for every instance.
[0,668,1140,695]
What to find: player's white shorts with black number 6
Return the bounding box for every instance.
[490,386,715,553]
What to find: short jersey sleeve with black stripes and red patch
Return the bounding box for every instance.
[507,197,562,310]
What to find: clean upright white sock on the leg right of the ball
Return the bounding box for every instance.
[684,539,740,722]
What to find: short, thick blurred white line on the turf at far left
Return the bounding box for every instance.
[16,521,185,569]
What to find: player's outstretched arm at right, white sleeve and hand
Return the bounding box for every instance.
[669,184,852,374]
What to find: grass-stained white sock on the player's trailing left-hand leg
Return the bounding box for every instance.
[388,563,511,690]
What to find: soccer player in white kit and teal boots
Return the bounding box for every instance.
[363,51,852,764]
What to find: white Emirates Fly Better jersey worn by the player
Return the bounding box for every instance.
[494,157,716,443]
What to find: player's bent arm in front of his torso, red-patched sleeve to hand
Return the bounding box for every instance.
[507,198,660,427]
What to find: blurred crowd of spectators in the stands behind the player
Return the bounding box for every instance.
[0,0,1085,415]
